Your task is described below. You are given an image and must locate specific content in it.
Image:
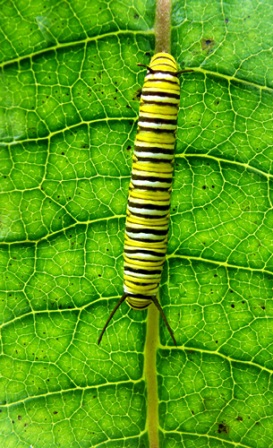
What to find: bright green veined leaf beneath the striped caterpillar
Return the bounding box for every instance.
[0,0,273,448]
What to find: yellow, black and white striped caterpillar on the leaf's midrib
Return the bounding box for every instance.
[98,53,180,345]
